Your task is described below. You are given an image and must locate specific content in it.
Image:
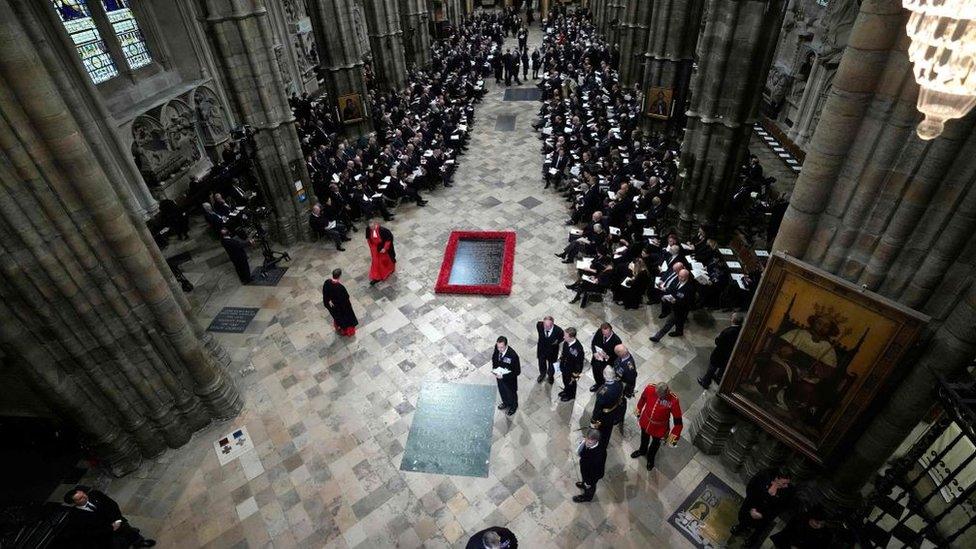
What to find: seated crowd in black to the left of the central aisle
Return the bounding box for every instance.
[286,14,524,248]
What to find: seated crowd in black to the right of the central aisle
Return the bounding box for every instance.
[536,11,758,328]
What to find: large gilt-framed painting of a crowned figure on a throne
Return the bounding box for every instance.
[720,253,929,464]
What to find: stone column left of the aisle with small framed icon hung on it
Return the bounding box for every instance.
[309,0,372,135]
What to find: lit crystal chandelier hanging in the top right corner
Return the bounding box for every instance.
[902,0,976,139]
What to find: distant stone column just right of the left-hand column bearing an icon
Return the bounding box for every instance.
[363,0,407,90]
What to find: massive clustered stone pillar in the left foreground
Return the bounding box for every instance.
[0,0,243,474]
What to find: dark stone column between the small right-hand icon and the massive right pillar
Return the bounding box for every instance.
[672,0,786,238]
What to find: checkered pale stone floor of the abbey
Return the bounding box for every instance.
[55,28,756,548]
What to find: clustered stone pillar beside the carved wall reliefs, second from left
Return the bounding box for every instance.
[199,0,311,244]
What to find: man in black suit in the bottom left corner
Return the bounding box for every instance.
[64,486,156,549]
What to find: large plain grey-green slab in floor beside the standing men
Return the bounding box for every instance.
[400,383,496,477]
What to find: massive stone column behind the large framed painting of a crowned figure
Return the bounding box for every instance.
[774,0,976,505]
